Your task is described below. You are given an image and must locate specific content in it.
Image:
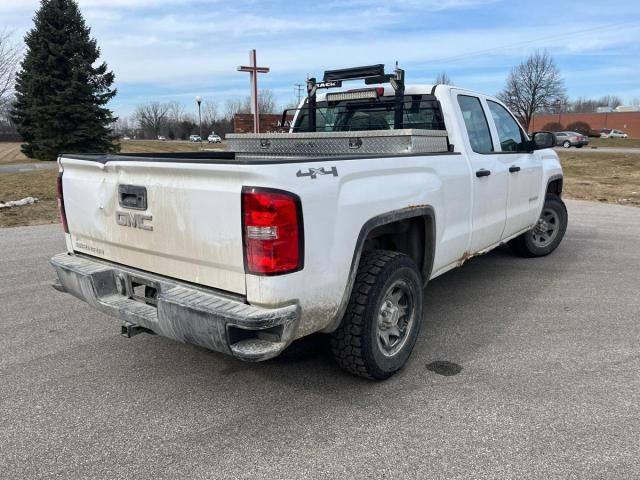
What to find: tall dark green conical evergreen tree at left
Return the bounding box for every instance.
[12,0,118,160]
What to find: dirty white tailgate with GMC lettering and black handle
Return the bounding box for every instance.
[60,156,245,294]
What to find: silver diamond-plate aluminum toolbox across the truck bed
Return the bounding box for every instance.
[226,129,448,157]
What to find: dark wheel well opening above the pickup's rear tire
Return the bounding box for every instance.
[363,215,435,280]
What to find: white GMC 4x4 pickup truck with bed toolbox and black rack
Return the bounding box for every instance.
[51,65,567,379]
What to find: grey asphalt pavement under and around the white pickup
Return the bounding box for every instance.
[0,201,640,480]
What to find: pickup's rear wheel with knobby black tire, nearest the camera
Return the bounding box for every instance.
[330,250,423,380]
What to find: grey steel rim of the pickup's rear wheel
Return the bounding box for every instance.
[376,279,416,357]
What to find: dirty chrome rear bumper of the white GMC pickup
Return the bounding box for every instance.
[51,253,299,361]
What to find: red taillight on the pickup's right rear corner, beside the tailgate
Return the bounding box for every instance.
[242,187,304,275]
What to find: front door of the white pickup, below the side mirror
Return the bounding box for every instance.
[487,100,543,238]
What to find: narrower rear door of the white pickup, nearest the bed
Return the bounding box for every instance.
[454,93,508,253]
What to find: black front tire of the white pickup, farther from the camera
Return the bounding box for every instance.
[509,193,569,257]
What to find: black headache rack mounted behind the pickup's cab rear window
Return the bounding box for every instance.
[307,62,404,132]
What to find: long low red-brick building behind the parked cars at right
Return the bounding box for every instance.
[529,112,640,138]
